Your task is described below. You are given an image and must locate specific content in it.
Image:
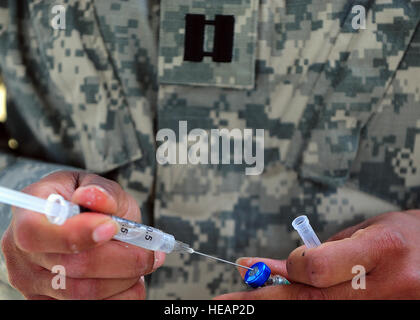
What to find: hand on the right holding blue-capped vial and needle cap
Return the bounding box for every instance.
[216,210,420,300]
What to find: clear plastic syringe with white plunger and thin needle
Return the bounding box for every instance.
[0,187,252,270]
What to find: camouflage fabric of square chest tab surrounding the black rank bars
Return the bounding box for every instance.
[158,0,259,89]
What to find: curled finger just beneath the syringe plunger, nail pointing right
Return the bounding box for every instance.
[12,209,119,253]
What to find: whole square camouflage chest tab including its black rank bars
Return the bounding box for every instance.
[159,0,258,89]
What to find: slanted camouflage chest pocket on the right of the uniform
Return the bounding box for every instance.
[287,1,419,186]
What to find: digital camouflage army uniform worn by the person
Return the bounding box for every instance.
[0,0,420,299]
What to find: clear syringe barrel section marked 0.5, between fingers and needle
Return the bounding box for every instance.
[112,216,176,253]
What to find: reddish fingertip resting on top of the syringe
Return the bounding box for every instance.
[71,175,140,222]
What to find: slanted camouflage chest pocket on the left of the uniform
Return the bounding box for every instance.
[28,0,143,172]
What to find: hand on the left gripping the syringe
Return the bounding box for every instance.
[2,172,165,299]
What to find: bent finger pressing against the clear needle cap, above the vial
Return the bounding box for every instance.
[287,225,405,288]
